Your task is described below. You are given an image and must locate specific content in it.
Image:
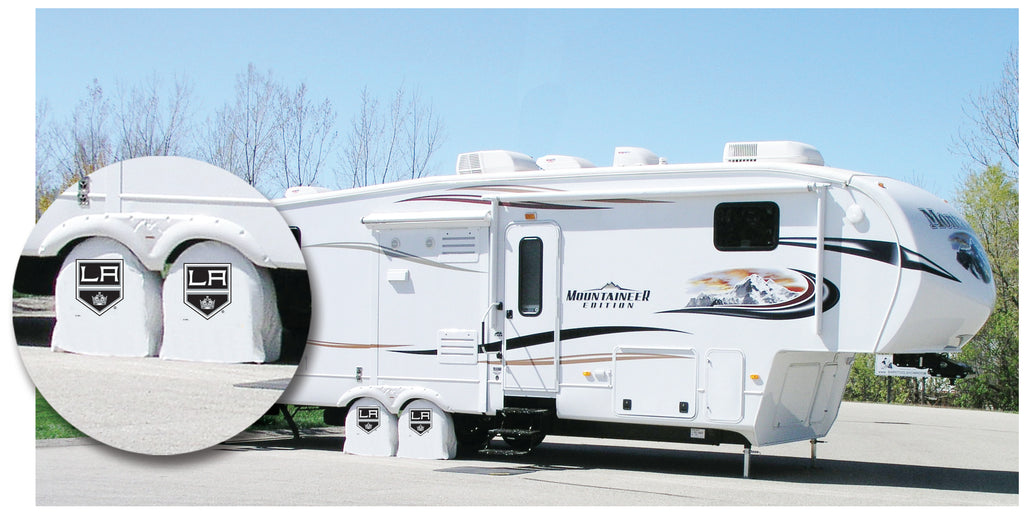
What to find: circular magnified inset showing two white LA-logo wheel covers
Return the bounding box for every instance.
[13,157,310,455]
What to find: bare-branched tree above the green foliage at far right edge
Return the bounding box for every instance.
[954,48,1020,179]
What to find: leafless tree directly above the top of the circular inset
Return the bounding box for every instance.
[117,75,193,160]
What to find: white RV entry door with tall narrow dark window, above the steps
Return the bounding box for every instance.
[502,223,561,396]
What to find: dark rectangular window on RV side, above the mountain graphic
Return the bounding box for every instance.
[715,202,778,252]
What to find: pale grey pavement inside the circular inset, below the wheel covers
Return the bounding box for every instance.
[18,346,295,455]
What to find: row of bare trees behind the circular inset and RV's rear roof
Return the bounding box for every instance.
[36,63,445,217]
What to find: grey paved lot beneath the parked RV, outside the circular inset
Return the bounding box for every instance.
[36,402,1020,506]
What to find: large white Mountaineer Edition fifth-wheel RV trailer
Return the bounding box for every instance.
[274,141,994,460]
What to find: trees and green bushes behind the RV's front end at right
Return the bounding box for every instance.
[846,49,1020,412]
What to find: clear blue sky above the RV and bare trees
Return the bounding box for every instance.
[29,9,1019,198]
